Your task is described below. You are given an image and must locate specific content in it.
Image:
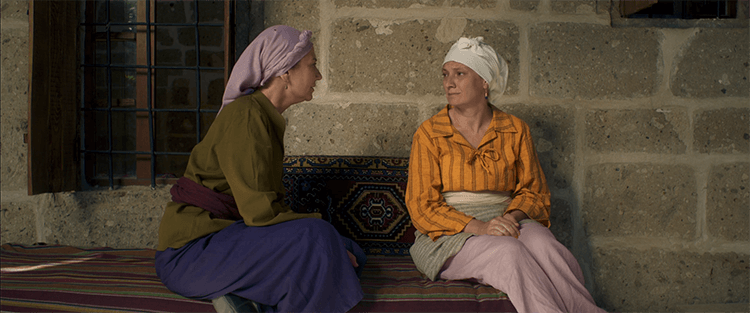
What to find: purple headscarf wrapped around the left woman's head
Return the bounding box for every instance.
[219,25,313,112]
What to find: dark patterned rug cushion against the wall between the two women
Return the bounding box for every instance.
[284,156,415,256]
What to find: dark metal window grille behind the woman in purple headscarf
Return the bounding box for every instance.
[80,0,234,188]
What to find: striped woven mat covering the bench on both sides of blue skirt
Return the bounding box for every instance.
[0,244,516,312]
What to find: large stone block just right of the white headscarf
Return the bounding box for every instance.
[529,23,661,99]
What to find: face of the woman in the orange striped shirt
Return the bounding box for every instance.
[443,61,487,107]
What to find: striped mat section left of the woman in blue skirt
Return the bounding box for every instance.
[0,244,216,312]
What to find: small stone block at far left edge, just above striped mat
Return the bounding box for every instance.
[0,201,37,245]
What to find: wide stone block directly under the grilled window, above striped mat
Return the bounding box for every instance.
[43,186,171,248]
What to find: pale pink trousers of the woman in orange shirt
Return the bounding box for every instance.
[440,223,604,313]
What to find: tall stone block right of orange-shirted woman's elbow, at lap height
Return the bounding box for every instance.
[582,164,697,240]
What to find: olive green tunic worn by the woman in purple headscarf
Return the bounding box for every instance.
[157,91,321,251]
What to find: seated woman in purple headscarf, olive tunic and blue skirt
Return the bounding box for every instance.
[156,25,366,312]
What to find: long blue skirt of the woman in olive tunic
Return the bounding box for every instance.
[155,218,367,312]
